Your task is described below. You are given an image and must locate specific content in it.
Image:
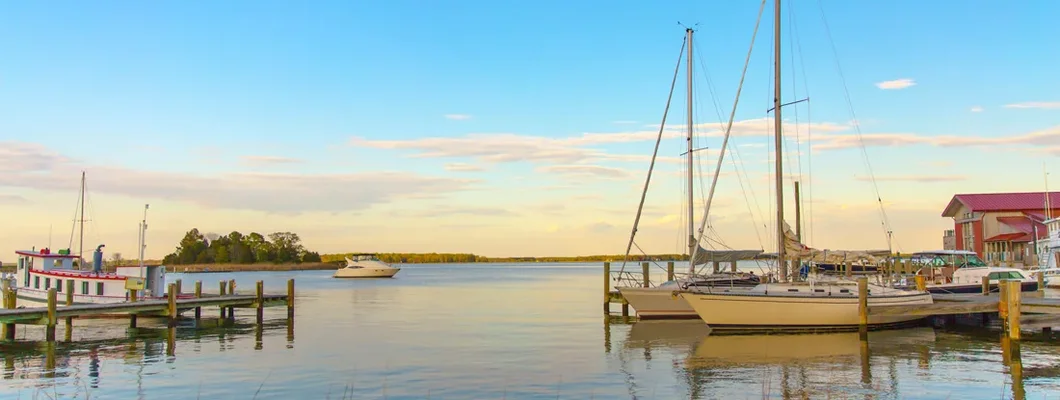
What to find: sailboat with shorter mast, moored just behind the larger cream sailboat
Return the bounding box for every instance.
[616,28,762,319]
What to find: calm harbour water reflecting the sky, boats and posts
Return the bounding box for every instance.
[0,264,1060,399]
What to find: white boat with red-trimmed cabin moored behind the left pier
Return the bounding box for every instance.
[5,172,165,307]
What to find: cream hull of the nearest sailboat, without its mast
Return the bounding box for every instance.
[681,286,932,328]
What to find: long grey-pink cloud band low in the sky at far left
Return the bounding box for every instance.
[0,142,479,213]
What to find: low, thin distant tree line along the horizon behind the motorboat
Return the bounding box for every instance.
[320,253,688,264]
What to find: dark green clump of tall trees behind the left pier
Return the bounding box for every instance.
[162,228,321,265]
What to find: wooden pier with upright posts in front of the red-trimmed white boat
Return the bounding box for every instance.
[0,279,295,345]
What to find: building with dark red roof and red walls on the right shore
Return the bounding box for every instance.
[942,192,1060,265]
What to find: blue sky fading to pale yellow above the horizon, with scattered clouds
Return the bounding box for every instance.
[0,0,1060,261]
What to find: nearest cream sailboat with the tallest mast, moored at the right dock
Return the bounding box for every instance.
[679,0,933,328]
